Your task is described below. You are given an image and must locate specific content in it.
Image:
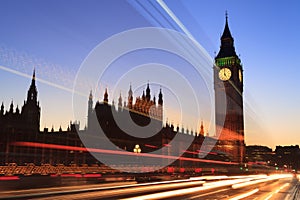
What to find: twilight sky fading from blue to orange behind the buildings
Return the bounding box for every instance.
[0,0,300,148]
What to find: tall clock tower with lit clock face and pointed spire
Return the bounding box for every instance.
[214,13,245,162]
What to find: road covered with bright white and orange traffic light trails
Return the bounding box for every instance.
[0,174,299,200]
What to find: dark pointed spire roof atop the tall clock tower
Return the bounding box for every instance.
[216,11,237,58]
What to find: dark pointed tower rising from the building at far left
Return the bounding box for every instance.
[21,70,41,133]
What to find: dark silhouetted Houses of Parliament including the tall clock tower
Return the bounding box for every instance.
[0,16,245,166]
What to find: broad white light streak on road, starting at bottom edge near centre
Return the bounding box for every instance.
[124,179,253,200]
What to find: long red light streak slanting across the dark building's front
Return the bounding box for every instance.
[11,141,239,165]
